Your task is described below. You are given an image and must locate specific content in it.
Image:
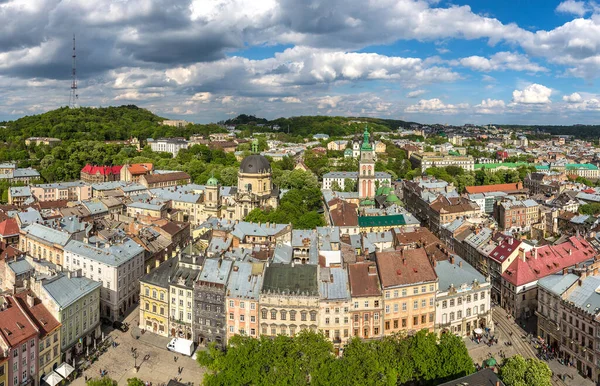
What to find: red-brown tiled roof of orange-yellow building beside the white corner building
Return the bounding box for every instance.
[375,248,437,288]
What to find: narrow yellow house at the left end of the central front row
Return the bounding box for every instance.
[140,262,172,336]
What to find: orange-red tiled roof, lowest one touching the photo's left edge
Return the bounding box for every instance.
[0,296,38,347]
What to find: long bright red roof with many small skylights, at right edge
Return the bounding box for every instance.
[502,236,597,286]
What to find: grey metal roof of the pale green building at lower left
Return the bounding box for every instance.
[42,274,102,309]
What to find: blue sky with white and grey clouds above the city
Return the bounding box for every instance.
[0,0,600,124]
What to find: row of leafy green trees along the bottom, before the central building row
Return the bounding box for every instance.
[197,330,475,386]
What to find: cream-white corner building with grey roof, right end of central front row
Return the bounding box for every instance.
[435,256,492,336]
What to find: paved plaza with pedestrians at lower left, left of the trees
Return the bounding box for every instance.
[73,308,204,386]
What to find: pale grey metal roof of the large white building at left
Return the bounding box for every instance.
[65,239,144,267]
